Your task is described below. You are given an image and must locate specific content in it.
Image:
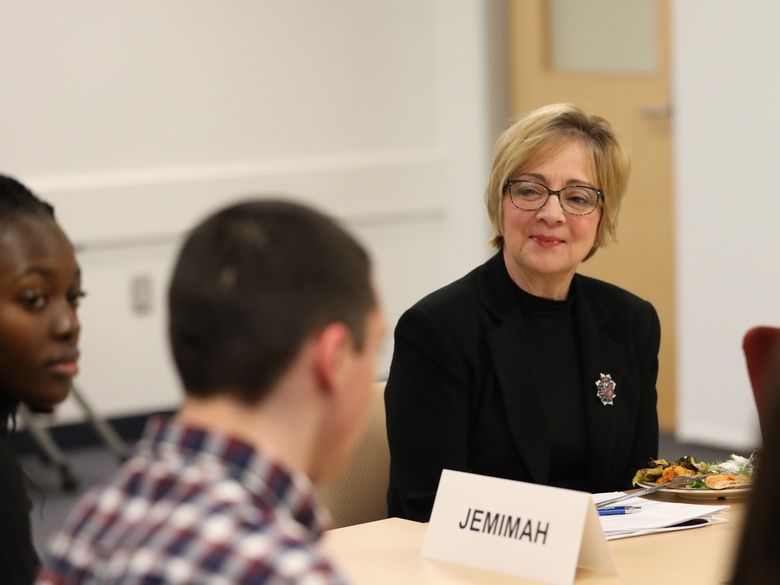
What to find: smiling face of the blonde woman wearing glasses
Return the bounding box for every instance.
[501,141,601,298]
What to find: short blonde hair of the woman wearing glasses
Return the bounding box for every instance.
[485,104,630,259]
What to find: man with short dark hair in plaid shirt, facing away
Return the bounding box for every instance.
[39,200,383,585]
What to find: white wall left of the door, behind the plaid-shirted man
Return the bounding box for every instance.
[0,0,505,420]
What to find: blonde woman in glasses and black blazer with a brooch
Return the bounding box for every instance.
[385,104,660,521]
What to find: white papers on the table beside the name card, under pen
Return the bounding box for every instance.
[593,492,728,540]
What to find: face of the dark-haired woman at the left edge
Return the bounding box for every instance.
[0,215,83,411]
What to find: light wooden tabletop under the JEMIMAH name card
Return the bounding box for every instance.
[324,501,745,585]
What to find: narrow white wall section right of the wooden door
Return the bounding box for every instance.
[672,0,780,447]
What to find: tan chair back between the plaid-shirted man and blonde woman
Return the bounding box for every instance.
[317,382,390,528]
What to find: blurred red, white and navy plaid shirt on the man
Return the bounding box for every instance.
[38,418,344,585]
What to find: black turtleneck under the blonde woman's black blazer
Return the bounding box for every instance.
[517,284,589,491]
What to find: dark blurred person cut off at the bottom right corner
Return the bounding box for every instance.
[731,354,780,585]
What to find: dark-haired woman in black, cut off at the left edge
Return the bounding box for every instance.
[0,175,83,585]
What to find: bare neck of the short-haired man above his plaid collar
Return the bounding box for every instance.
[178,376,318,475]
